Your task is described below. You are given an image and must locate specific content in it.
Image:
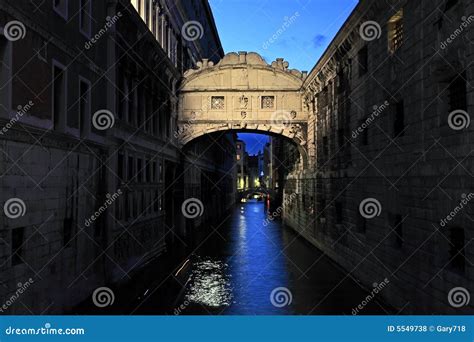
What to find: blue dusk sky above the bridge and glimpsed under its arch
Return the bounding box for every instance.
[209,0,358,154]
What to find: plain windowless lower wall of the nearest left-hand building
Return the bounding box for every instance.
[0,139,104,314]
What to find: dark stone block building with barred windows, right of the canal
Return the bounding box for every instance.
[285,0,474,314]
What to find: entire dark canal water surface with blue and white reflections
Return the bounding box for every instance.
[80,201,389,315]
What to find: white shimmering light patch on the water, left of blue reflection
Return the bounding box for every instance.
[185,259,233,307]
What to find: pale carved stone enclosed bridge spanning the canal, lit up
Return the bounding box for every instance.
[176,52,308,167]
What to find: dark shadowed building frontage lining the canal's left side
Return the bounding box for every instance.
[0,0,235,314]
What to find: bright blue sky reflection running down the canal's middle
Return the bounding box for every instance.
[225,201,290,314]
